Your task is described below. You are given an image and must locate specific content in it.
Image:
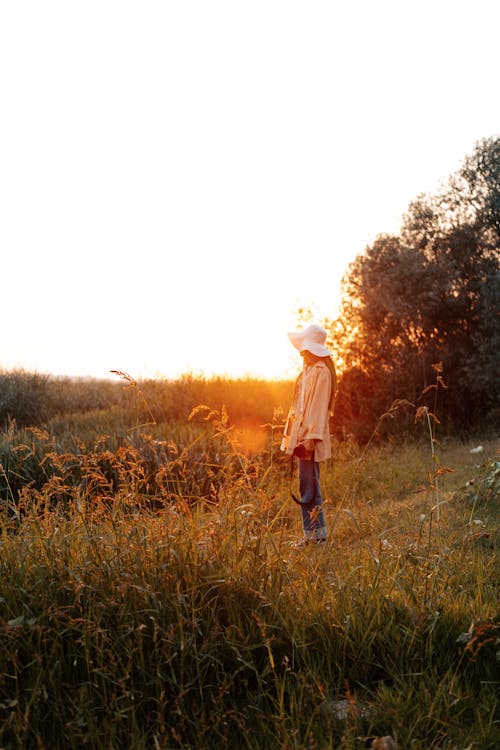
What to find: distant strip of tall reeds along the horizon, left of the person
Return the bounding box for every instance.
[0,370,292,429]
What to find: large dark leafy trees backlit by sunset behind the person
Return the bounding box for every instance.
[330,138,500,437]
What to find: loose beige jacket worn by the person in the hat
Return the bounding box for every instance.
[281,361,332,461]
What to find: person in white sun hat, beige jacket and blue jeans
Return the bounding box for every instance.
[281,325,337,544]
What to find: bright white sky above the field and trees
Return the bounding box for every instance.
[0,0,500,378]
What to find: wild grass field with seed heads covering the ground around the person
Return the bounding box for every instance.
[0,381,500,750]
